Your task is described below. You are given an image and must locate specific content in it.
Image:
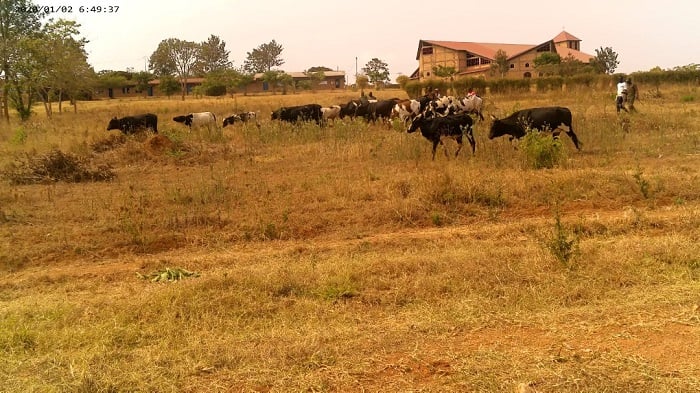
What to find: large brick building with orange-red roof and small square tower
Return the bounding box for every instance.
[411,31,595,80]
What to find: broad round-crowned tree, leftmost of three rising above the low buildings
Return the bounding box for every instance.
[149,38,199,101]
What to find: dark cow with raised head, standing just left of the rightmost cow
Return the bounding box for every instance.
[407,113,476,160]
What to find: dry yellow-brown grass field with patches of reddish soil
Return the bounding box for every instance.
[0,85,700,393]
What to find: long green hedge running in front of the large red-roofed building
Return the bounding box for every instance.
[401,65,700,97]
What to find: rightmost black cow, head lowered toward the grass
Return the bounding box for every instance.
[489,106,581,150]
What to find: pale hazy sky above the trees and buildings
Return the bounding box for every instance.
[50,0,700,83]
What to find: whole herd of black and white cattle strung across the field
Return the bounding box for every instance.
[107,95,580,160]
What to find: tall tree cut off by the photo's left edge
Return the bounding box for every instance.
[0,0,42,122]
